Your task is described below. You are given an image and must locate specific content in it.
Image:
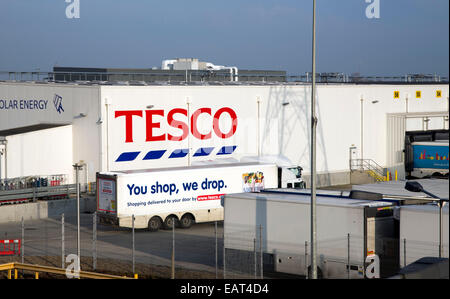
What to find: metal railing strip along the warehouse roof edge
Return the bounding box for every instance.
[0,69,449,85]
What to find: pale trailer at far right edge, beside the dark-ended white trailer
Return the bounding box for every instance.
[400,203,449,267]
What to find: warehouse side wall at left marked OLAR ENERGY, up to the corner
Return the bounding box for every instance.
[0,82,101,183]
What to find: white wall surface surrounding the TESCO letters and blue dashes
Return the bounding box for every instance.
[0,83,448,186]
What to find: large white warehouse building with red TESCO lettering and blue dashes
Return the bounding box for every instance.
[0,82,448,185]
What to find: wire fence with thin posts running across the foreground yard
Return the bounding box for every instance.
[0,213,448,279]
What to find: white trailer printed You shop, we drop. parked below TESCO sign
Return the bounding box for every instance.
[97,163,301,231]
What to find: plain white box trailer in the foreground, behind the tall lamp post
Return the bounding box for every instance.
[224,191,398,278]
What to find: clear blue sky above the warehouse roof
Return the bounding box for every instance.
[0,0,449,76]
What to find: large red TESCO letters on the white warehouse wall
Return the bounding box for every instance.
[114,107,238,142]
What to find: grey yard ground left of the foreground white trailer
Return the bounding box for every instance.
[0,214,223,273]
